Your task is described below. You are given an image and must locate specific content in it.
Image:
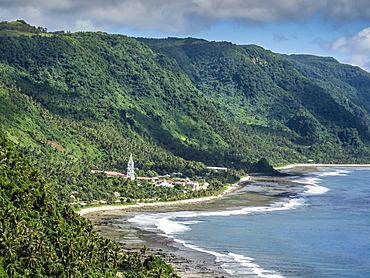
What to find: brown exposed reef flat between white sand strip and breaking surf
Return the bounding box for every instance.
[84,172,306,278]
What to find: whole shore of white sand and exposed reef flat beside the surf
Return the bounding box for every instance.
[78,170,297,278]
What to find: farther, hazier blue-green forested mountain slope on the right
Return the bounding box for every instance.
[139,38,370,152]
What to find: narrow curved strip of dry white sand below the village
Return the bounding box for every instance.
[76,176,250,216]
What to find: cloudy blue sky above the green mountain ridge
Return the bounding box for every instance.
[0,0,370,72]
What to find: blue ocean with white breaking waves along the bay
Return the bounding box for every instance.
[129,167,370,278]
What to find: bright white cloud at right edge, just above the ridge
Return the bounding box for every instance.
[330,27,370,71]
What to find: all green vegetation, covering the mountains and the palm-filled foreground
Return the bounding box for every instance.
[0,20,370,277]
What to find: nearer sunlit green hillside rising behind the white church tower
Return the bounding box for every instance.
[0,22,246,198]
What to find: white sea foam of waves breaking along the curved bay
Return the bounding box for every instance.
[129,170,336,278]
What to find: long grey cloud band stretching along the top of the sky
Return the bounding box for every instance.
[0,0,370,33]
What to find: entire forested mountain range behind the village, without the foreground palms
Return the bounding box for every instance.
[0,20,370,200]
